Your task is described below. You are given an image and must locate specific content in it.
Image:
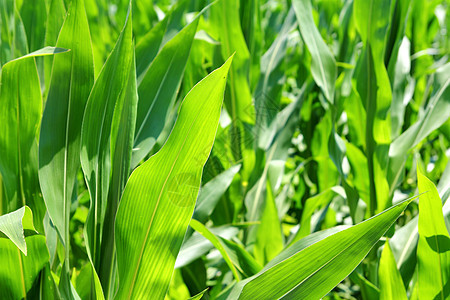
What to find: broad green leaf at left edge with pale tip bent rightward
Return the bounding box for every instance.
[0,47,66,231]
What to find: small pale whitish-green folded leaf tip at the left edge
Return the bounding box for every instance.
[0,206,36,256]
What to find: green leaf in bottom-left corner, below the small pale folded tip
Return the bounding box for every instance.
[0,235,49,299]
